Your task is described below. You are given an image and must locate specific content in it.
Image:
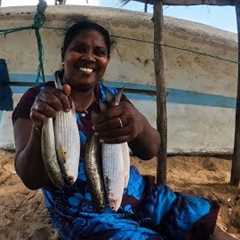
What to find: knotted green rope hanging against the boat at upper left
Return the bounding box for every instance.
[0,0,47,83]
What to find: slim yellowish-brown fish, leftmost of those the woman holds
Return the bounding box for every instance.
[41,118,64,188]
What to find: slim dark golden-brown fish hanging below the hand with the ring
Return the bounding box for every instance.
[84,134,106,210]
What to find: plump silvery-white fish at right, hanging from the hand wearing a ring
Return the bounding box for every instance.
[100,89,130,211]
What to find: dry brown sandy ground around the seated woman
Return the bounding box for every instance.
[0,150,240,240]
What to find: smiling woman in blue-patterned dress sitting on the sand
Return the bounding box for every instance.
[13,21,231,240]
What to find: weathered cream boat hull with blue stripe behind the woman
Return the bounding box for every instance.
[0,5,237,154]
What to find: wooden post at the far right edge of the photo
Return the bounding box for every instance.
[230,2,240,186]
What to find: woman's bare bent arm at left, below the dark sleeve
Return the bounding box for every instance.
[14,118,51,189]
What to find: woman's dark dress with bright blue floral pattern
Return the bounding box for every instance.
[13,82,219,240]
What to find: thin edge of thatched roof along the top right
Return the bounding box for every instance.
[122,0,239,6]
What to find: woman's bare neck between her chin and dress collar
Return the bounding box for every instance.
[71,89,95,112]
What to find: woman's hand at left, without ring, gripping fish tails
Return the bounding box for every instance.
[30,84,72,127]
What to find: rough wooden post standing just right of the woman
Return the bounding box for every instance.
[153,0,167,184]
